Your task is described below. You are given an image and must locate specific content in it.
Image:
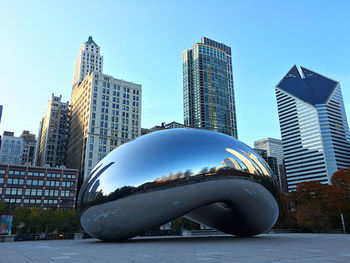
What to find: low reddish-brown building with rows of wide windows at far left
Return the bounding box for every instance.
[0,164,78,209]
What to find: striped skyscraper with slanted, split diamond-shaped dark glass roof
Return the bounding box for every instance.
[276,66,350,190]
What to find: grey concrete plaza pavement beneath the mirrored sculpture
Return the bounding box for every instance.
[0,234,350,263]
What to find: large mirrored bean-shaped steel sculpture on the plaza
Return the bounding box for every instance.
[78,129,279,241]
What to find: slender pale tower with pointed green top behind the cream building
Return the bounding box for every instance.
[72,36,103,89]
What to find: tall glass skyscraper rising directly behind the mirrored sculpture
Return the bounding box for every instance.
[182,37,237,138]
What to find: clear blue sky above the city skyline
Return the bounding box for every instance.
[0,0,350,145]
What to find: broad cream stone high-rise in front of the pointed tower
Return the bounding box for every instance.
[67,72,142,177]
